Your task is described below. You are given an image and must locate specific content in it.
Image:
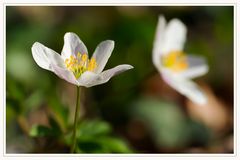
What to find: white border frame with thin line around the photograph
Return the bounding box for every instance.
[0,0,240,160]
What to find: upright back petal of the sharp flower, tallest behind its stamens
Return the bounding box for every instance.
[61,32,88,60]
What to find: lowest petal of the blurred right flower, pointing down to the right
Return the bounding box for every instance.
[163,74,207,105]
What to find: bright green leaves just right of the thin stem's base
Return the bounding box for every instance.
[74,120,132,153]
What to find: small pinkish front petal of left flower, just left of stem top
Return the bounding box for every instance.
[51,64,79,86]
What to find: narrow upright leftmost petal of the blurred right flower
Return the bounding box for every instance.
[152,15,166,68]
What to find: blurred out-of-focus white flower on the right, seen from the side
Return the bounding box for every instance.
[152,16,208,104]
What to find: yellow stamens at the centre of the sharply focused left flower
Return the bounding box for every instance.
[65,52,97,79]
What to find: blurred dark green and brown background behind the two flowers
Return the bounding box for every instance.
[6,6,233,153]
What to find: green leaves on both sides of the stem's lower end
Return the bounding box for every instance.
[29,117,132,153]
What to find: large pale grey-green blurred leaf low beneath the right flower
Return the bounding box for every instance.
[131,97,190,148]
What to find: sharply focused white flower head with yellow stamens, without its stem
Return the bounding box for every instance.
[32,33,133,87]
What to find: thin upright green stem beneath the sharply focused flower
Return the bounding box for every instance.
[71,86,80,153]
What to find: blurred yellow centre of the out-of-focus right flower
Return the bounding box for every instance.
[162,51,188,72]
